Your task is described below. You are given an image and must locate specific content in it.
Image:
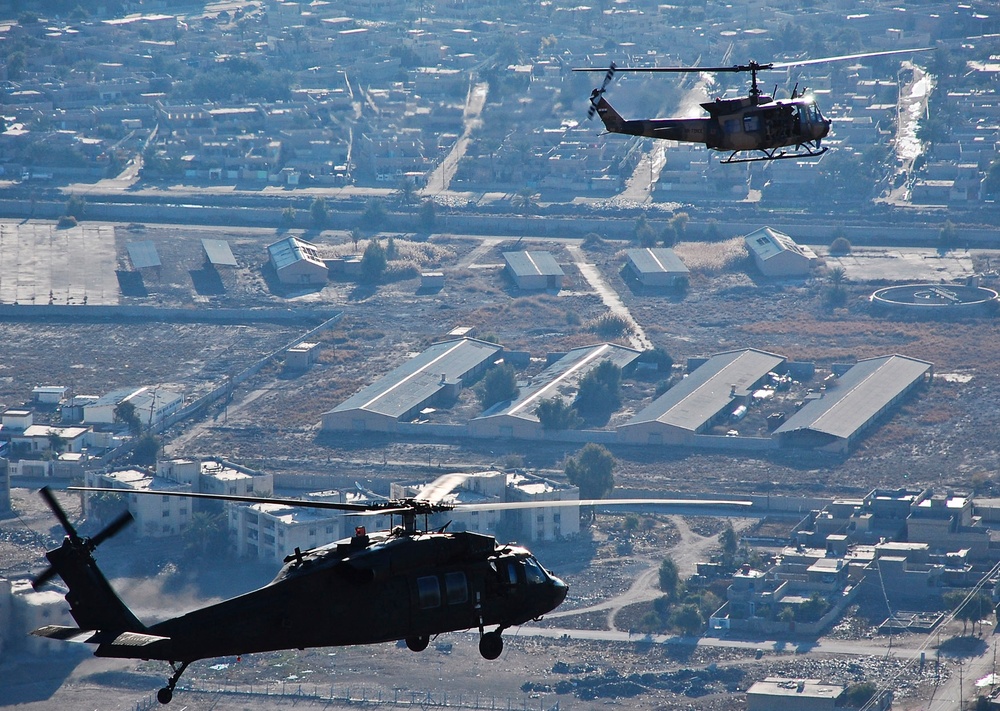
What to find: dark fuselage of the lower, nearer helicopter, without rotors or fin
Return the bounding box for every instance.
[86,532,567,662]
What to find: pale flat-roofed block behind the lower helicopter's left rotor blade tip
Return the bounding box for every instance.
[84,469,194,538]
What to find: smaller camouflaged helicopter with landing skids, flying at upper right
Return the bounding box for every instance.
[573,47,934,163]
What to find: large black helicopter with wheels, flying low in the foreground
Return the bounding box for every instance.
[32,474,750,704]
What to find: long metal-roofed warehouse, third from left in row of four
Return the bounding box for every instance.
[617,348,786,445]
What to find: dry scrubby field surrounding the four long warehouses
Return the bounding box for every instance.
[0,222,1000,506]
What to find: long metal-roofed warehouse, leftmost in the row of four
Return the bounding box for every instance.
[322,338,503,432]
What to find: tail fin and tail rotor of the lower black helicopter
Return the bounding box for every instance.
[32,487,146,641]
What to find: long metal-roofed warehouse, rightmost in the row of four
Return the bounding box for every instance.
[774,355,934,452]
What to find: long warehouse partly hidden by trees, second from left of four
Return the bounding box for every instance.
[469,343,641,439]
